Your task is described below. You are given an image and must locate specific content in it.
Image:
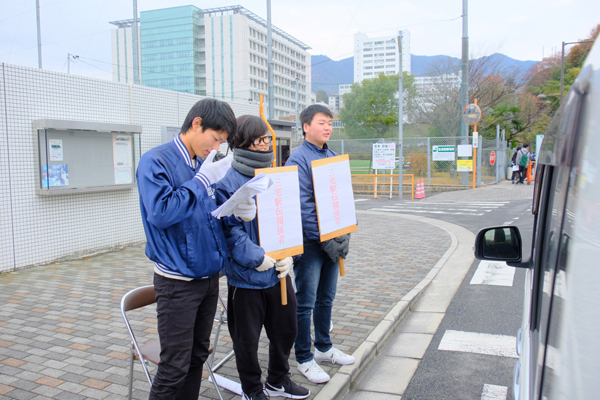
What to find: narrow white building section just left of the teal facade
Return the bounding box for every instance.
[110,19,142,83]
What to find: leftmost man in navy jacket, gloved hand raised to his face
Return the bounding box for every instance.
[137,99,256,400]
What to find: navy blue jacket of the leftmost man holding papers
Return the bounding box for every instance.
[136,137,227,279]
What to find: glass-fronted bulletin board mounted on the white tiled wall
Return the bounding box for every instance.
[33,120,142,195]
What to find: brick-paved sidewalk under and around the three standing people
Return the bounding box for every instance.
[0,211,452,399]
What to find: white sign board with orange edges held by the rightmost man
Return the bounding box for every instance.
[311,154,356,242]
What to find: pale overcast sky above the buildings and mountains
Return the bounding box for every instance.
[0,0,600,79]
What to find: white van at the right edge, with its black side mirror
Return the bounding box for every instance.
[475,38,600,400]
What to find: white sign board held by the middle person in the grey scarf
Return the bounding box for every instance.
[256,165,304,260]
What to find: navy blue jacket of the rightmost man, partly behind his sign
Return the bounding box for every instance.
[285,140,338,242]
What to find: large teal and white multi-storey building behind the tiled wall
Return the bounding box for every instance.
[113,5,311,118]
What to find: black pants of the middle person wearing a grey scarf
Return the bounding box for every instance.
[227,275,298,394]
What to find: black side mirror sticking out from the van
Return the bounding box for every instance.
[474,226,522,266]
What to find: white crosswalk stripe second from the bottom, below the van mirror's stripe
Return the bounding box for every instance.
[438,330,519,358]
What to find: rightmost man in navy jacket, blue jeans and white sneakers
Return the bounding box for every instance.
[285,104,354,383]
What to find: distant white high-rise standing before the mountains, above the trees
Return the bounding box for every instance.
[354,30,410,83]
